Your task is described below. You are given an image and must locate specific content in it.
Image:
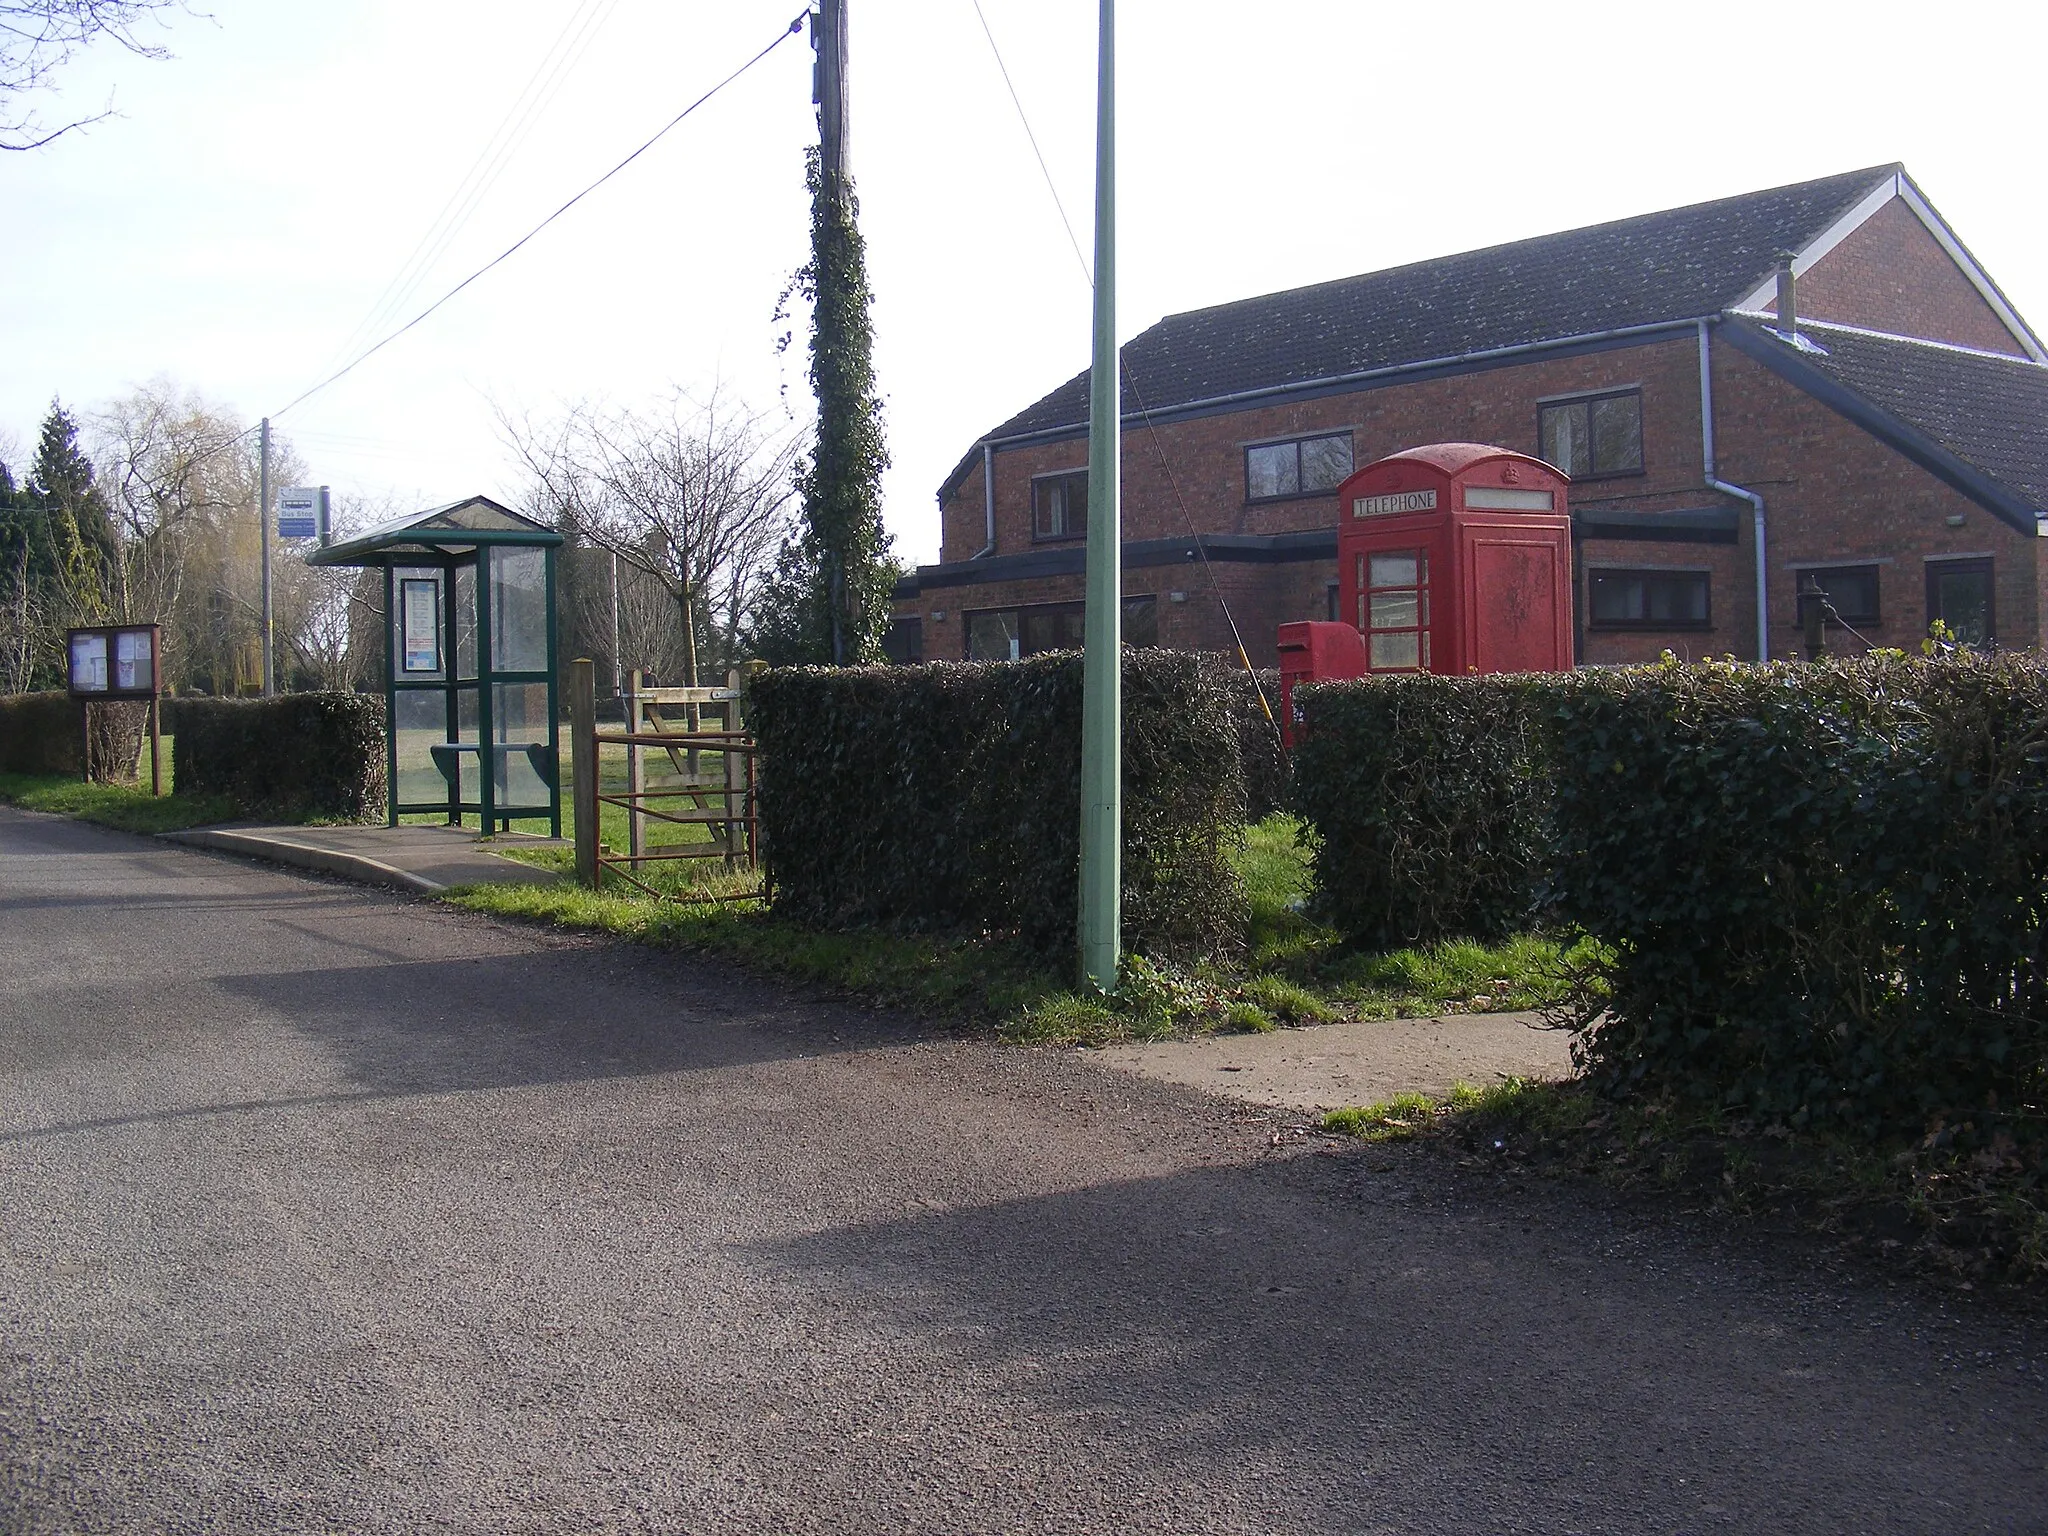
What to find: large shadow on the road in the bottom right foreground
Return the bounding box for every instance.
[756,1153,2048,1532]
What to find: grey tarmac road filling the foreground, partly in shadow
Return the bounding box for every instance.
[0,811,2048,1536]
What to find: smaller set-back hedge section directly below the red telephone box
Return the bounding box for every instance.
[1290,676,1571,950]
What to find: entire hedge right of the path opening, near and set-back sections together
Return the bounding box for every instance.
[1294,651,2048,1147]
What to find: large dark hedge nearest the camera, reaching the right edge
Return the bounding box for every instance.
[1550,653,2048,1141]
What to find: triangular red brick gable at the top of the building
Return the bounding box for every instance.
[1767,197,2025,356]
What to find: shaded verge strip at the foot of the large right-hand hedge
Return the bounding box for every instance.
[1321,1077,2048,1294]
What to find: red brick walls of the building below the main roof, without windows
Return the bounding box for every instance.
[921,331,2048,666]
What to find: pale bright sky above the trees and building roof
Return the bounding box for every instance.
[0,0,2048,561]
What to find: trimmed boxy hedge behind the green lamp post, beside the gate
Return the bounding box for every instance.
[750,651,1247,961]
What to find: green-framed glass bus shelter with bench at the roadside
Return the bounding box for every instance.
[307,496,561,838]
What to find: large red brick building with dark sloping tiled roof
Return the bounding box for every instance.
[893,166,2048,666]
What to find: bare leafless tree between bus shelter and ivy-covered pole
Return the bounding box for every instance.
[498,387,803,686]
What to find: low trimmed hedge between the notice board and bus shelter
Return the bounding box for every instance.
[166,692,385,821]
